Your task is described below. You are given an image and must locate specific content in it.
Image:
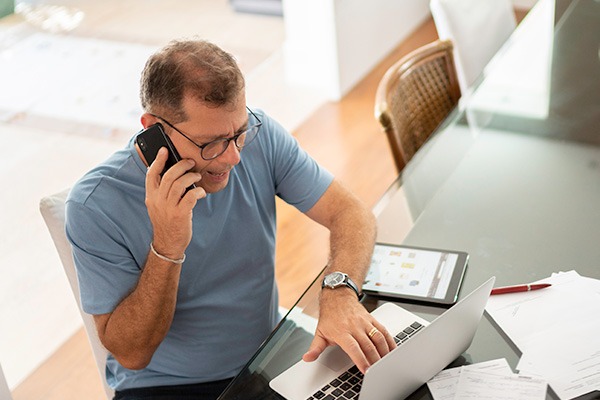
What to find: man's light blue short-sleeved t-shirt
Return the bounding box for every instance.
[66,111,333,390]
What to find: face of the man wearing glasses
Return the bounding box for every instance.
[163,95,248,193]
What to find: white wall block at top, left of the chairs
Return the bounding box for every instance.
[283,0,429,100]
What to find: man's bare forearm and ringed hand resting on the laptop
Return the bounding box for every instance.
[302,181,395,373]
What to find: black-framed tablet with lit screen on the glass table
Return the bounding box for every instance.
[362,243,469,306]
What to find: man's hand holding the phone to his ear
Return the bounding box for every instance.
[146,147,206,259]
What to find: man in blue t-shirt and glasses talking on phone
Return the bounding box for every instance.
[66,41,395,399]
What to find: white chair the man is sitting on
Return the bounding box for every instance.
[40,189,114,399]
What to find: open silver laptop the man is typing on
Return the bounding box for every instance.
[269,277,495,400]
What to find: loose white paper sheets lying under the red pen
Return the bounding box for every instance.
[486,271,600,399]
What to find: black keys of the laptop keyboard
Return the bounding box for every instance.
[306,321,423,400]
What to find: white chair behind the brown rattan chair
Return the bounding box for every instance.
[429,0,517,96]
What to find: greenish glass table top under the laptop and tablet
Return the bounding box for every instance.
[220,0,600,400]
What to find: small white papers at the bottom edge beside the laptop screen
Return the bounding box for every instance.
[427,358,546,400]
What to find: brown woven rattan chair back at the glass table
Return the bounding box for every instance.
[375,40,460,171]
